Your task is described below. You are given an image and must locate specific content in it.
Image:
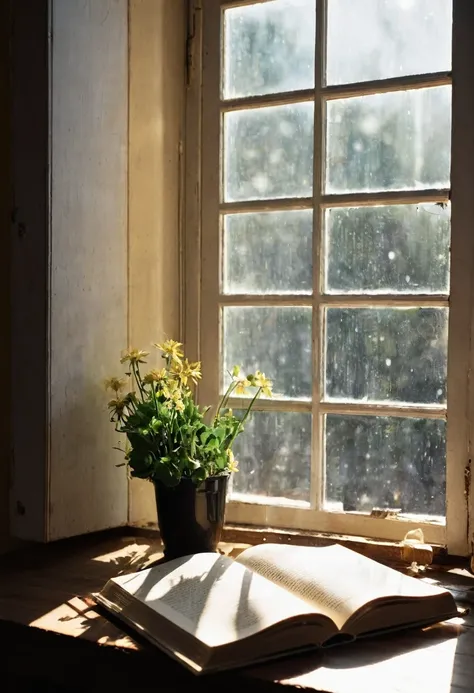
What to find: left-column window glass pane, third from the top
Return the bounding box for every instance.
[223,209,313,294]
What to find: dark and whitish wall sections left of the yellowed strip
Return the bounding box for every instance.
[10,0,128,541]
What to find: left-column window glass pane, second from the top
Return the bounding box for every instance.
[224,102,314,202]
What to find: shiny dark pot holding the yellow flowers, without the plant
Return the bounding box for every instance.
[154,476,229,560]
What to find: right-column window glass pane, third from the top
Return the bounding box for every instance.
[326,204,451,294]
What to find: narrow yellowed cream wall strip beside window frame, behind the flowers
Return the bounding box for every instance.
[129,0,186,525]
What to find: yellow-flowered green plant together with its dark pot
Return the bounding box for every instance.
[106,339,272,559]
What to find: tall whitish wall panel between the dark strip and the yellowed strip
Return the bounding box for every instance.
[47,0,128,539]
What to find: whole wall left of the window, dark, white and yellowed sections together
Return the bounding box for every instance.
[4,0,187,551]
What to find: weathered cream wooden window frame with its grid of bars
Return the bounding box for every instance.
[183,0,474,555]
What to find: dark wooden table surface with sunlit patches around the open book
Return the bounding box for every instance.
[0,533,474,693]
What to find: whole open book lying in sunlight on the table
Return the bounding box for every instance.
[95,544,457,673]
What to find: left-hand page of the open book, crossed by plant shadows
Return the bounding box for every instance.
[111,553,334,647]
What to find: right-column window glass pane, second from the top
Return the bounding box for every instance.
[326,86,451,193]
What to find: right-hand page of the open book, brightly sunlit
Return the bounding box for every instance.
[236,544,445,629]
